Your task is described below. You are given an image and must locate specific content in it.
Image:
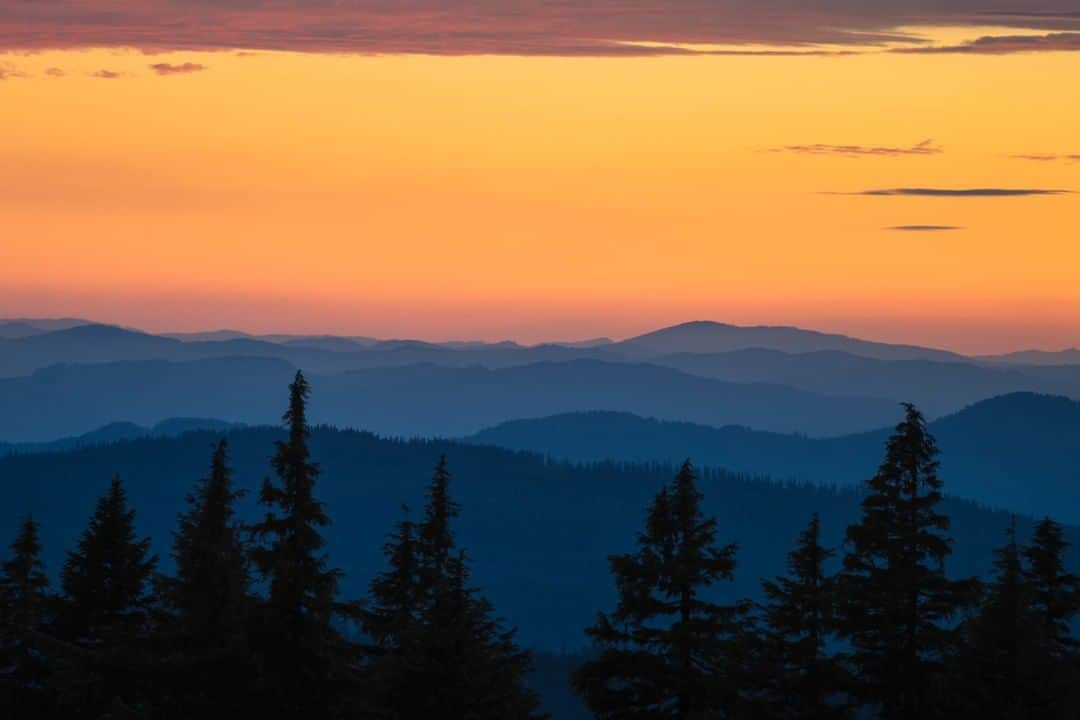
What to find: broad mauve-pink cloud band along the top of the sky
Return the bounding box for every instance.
[0,0,1080,57]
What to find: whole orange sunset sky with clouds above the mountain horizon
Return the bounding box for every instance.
[0,0,1080,352]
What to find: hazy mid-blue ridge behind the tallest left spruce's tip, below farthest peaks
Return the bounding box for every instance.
[0,357,895,443]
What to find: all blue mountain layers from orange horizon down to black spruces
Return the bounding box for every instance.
[0,320,1080,649]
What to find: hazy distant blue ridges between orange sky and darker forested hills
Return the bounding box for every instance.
[0,320,1080,443]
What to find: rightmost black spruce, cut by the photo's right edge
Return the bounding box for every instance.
[1024,517,1080,720]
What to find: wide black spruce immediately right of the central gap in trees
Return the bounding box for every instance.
[573,460,740,720]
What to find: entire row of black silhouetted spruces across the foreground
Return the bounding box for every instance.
[0,372,1080,720]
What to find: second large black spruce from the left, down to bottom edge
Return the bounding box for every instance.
[56,477,157,718]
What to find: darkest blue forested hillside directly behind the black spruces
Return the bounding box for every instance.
[0,427,1067,650]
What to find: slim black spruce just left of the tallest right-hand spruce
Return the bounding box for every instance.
[761,513,848,720]
